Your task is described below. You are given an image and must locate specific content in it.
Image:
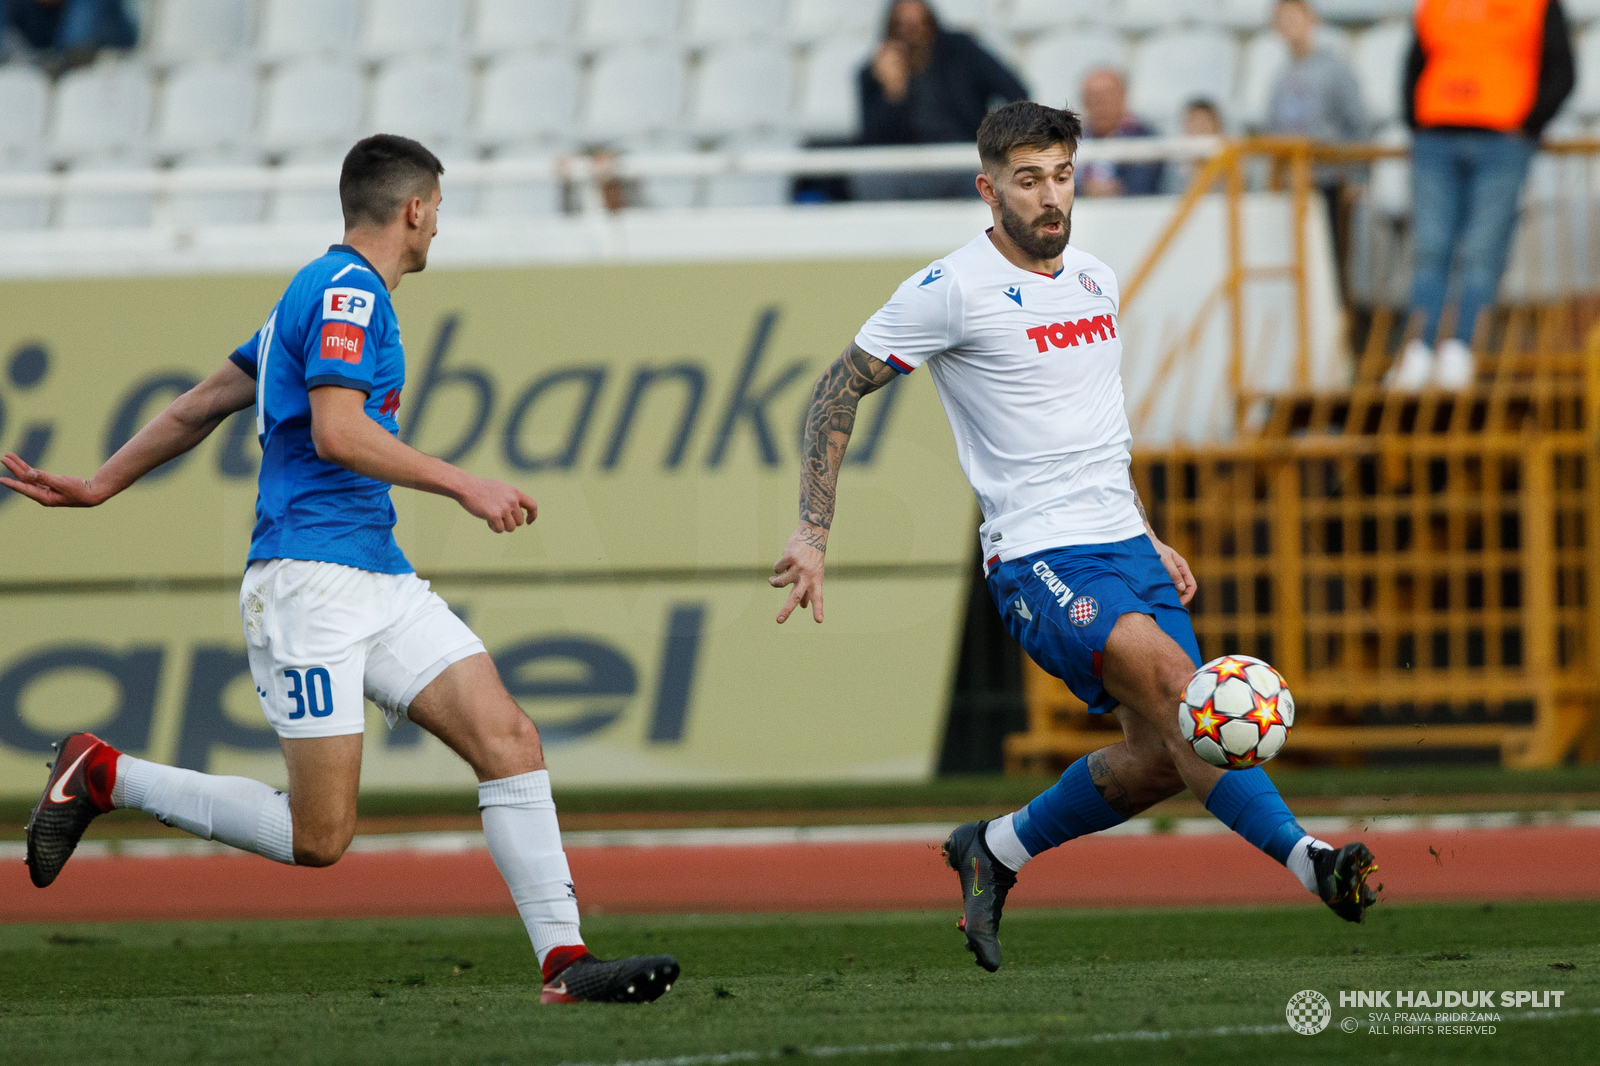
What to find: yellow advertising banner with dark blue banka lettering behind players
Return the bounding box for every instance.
[0,261,976,795]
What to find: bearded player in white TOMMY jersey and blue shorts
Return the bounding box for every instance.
[770,102,1374,972]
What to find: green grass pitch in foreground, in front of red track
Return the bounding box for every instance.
[0,903,1600,1066]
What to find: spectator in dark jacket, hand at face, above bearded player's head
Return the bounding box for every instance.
[854,0,1027,200]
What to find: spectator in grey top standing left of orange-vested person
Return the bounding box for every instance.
[1267,0,1366,296]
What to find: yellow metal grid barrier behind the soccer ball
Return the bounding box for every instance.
[1006,320,1600,771]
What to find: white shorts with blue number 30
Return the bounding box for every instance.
[238,559,483,738]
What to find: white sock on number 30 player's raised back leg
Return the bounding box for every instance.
[110,755,294,866]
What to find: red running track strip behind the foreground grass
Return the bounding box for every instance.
[0,828,1600,922]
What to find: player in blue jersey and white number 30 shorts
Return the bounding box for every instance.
[0,134,678,1004]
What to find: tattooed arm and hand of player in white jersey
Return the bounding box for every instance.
[766,343,896,623]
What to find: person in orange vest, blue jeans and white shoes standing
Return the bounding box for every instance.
[1387,0,1574,389]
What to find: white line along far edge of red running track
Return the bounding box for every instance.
[0,810,1600,861]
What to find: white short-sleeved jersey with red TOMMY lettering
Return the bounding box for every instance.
[856,232,1144,567]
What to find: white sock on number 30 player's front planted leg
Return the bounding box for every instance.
[478,770,584,967]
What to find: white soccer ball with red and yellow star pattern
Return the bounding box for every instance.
[1178,655,1294,770]
